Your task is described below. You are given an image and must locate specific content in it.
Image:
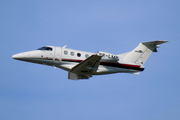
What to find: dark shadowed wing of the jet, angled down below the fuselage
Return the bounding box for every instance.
[68,55,102,80]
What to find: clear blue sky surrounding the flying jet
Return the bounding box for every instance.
[0,0,180,120]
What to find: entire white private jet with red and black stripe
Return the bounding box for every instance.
[12,40,168,80]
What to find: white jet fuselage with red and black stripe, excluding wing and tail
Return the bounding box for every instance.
[12,46,144,75]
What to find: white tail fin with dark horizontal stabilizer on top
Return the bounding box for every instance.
[123,40,167,64]
